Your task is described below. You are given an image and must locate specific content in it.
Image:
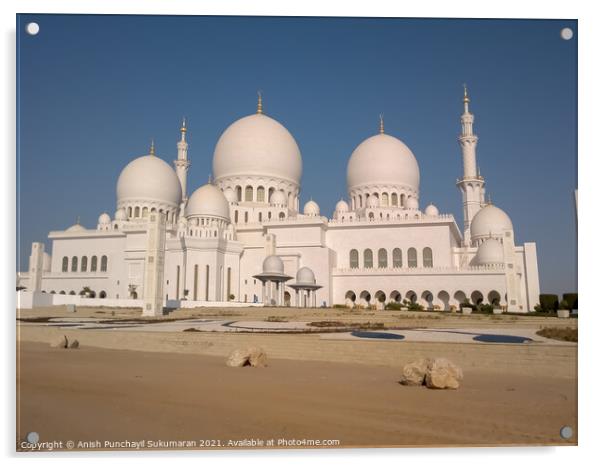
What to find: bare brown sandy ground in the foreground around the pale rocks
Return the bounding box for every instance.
[17,342,577,449]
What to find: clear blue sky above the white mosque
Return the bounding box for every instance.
[17,15,577,293]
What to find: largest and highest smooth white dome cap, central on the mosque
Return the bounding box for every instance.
[213,113,302,185]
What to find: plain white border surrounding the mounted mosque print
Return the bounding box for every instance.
[0,0,602,466]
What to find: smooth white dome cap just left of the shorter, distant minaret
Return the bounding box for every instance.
[117,155,182,207]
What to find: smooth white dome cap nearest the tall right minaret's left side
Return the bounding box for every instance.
[347,133,420,192]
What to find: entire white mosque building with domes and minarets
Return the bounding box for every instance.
[18,90,539,314]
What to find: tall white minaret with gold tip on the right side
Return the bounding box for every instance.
[456,84,485,246]
